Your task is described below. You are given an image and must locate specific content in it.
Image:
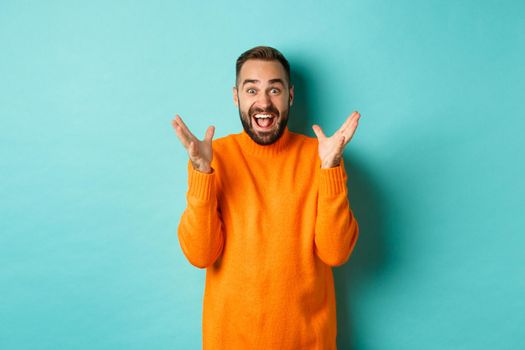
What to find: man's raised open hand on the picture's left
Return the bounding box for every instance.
[171,114,215,174]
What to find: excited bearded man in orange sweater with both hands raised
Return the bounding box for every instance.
[173,46,360,350]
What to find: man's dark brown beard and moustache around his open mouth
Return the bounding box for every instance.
[239,101,290,146]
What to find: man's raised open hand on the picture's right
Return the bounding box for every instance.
[312,111,361,168]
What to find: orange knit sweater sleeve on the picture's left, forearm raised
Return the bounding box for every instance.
[178,162,224,268]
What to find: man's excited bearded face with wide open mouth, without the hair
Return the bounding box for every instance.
[233,59,294,145]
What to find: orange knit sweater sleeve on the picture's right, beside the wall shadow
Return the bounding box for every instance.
[315,160,359,266]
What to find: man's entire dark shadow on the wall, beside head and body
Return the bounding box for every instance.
[289,62,390,350]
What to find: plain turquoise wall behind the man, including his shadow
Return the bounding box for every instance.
[0,0,525,350]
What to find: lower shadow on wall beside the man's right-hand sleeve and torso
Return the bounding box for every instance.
[334,156,386,349]
